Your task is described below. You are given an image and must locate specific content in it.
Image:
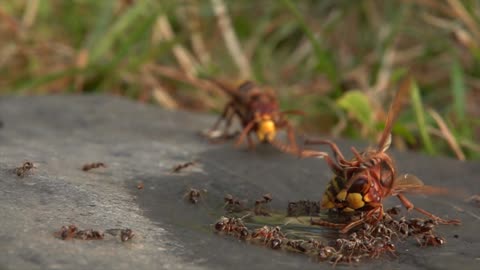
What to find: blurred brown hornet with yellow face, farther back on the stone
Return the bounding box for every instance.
[205,80,303,153]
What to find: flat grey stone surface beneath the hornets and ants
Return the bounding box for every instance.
[0,96,480,270]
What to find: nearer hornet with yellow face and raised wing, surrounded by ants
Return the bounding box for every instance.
[300,79,460,233]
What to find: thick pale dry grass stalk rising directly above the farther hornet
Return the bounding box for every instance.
[212,0,252,79]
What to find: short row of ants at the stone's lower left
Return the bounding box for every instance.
[54,224,135,242]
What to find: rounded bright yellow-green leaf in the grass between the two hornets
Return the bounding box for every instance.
[337,90,373,129]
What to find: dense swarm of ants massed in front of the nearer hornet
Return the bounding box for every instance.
[214,208,445,265]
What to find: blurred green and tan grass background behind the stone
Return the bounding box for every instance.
[0,0,480,160]
